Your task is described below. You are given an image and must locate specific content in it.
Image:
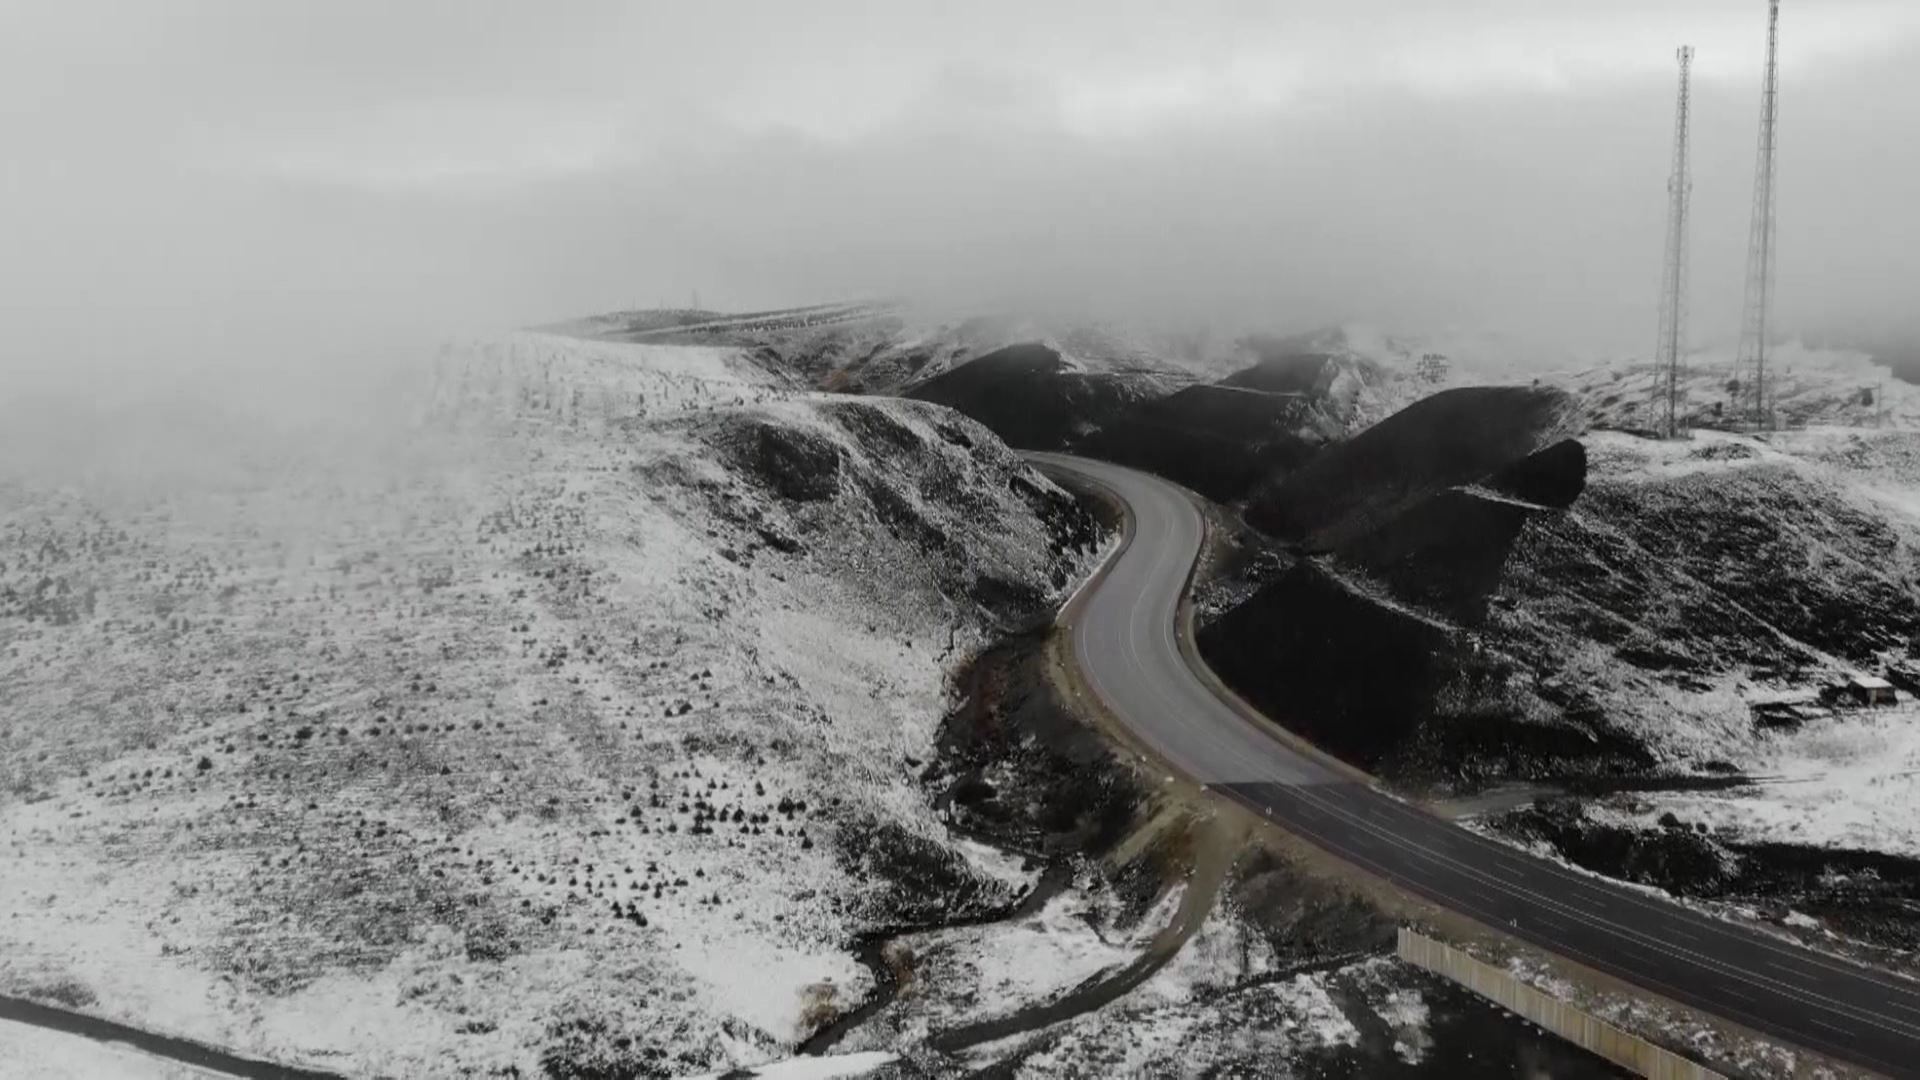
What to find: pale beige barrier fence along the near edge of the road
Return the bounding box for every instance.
[1396,926,1726,1080]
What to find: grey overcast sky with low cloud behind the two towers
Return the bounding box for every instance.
[0,0,1920,392]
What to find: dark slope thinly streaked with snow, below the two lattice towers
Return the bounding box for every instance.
[1496,453,1920,684]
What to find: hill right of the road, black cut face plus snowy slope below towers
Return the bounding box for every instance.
[1202,417,1920,782]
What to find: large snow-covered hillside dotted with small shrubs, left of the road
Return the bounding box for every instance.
[0,334,1089,1076]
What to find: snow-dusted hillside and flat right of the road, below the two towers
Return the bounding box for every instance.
[1451,425,1920,965]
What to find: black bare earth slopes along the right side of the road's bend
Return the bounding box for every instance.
[1200,388,1649,784]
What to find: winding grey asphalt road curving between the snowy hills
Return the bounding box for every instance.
[1031,454,1920,1076]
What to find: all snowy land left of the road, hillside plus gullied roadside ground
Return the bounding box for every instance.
[0,326,1643,1076]
